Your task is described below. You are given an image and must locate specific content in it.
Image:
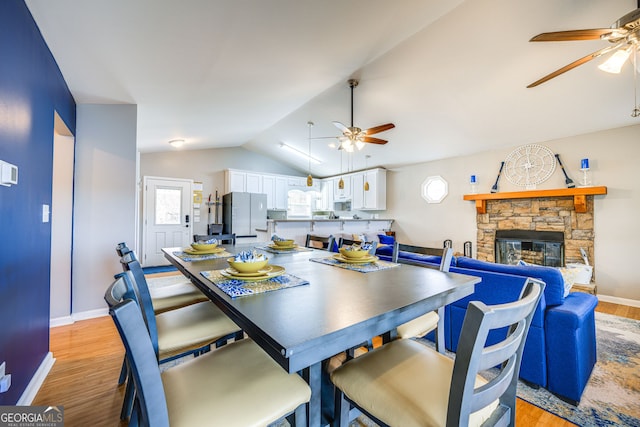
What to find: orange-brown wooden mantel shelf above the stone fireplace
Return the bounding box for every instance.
[462,187,607,214]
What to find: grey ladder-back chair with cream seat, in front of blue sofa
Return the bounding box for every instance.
[330,279,544,427]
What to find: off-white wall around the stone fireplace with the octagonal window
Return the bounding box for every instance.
[387,125,640,301]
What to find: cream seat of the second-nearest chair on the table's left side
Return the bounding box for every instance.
[156,302,240,360]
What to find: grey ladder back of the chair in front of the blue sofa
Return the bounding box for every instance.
[447,278,545,426]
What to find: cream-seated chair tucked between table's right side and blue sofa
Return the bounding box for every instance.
[391,242,453,353]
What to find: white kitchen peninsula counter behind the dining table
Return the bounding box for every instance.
[258,218,393,246]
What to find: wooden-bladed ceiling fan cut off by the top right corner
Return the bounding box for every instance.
[527,0,640,88]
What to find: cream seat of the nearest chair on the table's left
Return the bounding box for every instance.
[162,339,311,427]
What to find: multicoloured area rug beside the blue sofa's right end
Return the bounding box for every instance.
[518,312,640,427]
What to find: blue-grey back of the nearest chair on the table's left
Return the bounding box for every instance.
[109,298,169,427]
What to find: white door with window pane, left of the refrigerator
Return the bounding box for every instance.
[140,176,193,266]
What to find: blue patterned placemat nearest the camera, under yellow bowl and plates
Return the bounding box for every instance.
[200,270,309,298]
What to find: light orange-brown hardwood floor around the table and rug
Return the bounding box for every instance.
[33,284,640,427]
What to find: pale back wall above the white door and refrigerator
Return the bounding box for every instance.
[140,147,306,234]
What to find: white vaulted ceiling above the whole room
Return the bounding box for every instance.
[26,0,640,176]
